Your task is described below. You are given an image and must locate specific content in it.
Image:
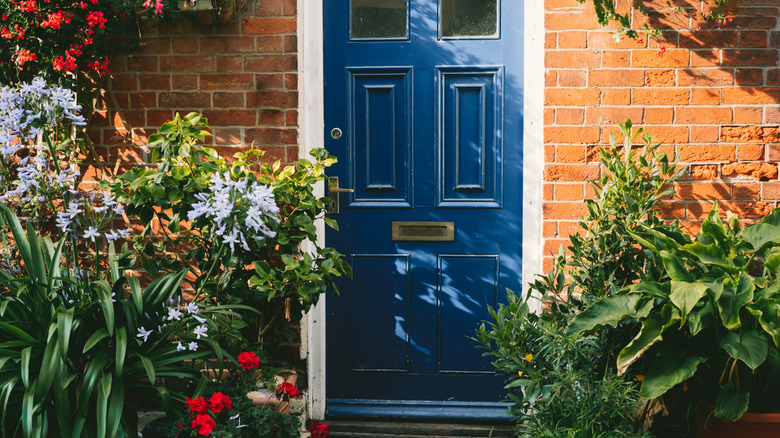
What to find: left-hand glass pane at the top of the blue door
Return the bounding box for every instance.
[350,0,408,40]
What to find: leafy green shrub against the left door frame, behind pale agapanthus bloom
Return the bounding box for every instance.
[106,113,351,352]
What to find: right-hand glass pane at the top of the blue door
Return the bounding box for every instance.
[439,0,496,38]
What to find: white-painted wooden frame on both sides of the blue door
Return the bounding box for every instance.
[298,0,544,419]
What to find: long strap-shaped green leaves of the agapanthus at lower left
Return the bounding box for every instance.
[0,205,221,437]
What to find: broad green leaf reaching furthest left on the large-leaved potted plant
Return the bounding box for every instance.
[566,294,653,336]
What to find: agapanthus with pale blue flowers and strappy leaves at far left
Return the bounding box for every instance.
[0,77,234,437]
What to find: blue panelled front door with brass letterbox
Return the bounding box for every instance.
[323,0,524,418]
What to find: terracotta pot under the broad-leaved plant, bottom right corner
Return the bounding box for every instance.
[696,402,780,438]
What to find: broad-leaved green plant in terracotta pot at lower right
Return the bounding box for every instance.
[567,204,780,437]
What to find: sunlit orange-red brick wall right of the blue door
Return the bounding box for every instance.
[543,0,780,270]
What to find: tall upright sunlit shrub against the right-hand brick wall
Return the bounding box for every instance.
[559,120,686,305]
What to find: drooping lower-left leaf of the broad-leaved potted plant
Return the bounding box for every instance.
[639,348,707,399]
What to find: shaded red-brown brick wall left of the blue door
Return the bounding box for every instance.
[89,0,298,176]
